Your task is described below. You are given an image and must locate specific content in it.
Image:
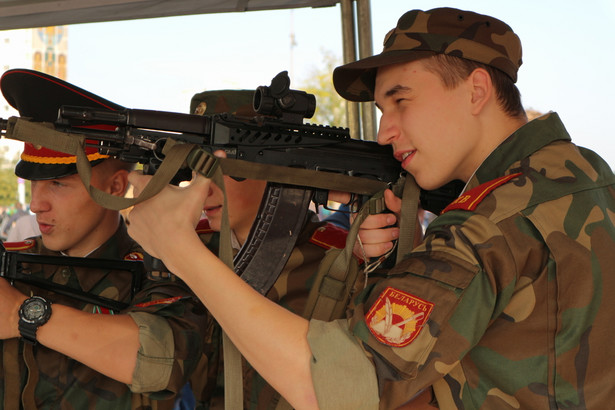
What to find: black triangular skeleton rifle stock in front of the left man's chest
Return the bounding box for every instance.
[0,243,144,312]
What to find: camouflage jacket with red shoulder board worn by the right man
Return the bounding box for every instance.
[308,113,615,409]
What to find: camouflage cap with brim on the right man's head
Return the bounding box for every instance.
[333,8,521,101]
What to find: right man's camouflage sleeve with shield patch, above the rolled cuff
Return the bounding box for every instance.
[336,212,519,408]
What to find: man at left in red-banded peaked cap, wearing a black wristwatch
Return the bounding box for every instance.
[0,71,207,410]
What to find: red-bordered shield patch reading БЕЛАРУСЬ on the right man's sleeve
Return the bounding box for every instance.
[365,287,434,347]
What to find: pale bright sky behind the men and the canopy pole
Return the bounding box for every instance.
[1,0,615,168]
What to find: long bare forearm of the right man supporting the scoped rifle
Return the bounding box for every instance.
[162,235,317,409]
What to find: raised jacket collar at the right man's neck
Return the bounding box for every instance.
[472,112,571,191]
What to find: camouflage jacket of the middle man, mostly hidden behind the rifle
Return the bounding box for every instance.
[192,212,347,410]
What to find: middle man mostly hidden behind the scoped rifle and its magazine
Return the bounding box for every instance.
[180,90,347,410]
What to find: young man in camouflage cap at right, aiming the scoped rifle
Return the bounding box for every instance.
[125,8,615,409]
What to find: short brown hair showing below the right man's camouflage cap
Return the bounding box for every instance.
[421,54,527,118]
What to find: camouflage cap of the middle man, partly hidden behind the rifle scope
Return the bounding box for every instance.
[190,90,257,117]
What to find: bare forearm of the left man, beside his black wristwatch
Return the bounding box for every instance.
[37,305,139,384]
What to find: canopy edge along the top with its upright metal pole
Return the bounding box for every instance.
[0,0,376,140]
